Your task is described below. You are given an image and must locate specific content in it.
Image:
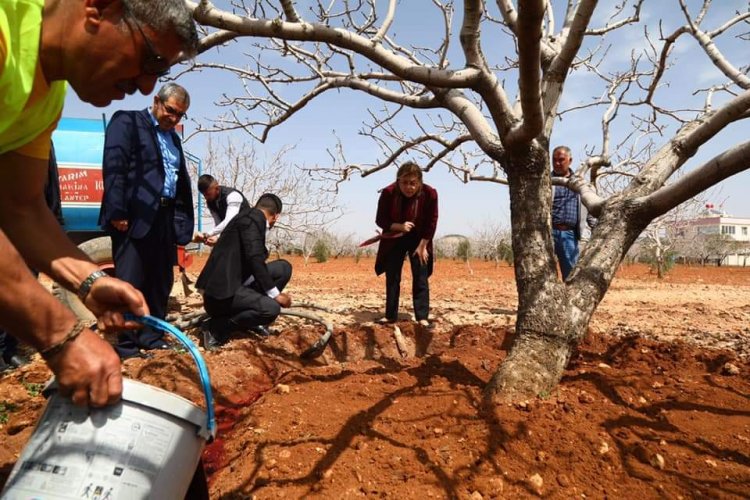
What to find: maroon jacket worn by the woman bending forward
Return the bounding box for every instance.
[375,182,438,275]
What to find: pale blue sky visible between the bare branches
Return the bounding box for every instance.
[63,0,750,238]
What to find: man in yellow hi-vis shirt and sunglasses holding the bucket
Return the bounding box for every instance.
[0,0,197,406]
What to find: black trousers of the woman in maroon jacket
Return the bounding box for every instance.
[385,238,432,321]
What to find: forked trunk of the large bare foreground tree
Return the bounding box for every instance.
[486,148,647,403]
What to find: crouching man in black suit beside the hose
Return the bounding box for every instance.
[196,193,292,349]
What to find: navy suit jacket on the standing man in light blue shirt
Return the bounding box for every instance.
[99,109,194,245]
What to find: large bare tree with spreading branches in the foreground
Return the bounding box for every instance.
[192,0,750,402]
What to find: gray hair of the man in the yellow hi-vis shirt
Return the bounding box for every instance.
[122,0,198,57]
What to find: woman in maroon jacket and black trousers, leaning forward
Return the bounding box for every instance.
[375,162,438,328]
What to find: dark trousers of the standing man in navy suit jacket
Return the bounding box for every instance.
[110,207,177,357]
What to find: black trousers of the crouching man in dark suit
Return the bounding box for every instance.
[203,259,292,340]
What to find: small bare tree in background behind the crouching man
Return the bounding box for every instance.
[200,139,343,252]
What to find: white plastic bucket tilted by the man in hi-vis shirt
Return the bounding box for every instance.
[2,379,209,500]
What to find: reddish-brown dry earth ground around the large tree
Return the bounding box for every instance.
[0,258,750,499]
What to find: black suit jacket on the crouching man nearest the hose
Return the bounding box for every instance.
[196,207,276,300]
